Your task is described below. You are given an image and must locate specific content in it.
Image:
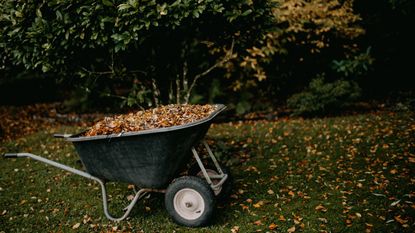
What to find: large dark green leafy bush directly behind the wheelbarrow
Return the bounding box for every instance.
[0,0,275,106]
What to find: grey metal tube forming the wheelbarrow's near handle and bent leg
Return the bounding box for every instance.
[4,153,155,221]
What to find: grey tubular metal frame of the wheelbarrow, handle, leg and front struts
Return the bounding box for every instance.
[3,140,228,221]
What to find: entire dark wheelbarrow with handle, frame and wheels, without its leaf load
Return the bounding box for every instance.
[4,104,230,227]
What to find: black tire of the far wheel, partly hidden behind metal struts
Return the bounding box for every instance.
[188,163,233,202]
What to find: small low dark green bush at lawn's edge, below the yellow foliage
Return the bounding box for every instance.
[287,77,361,116]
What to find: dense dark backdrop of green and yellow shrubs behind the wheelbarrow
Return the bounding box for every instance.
[0,0,415,113]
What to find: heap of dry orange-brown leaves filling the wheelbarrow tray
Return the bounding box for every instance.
[85,104,221,136]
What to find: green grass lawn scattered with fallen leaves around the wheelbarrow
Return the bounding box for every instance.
[0,109,415,232]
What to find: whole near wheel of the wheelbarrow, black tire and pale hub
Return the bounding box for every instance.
[164,176,215,227]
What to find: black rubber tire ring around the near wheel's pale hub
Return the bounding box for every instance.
[164,176,216,227]
